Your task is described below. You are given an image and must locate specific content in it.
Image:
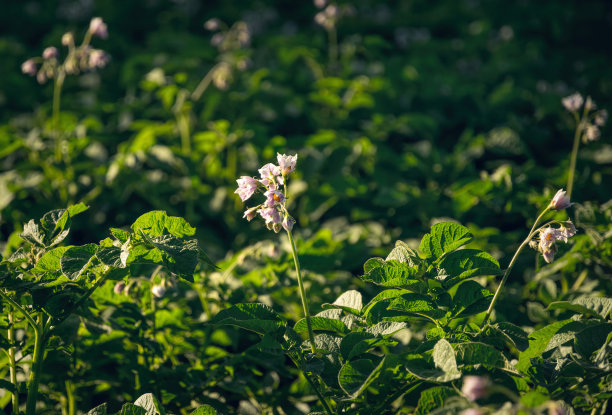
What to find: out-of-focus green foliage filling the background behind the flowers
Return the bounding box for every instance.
[0,0,612,407]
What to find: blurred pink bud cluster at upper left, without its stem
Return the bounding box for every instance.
[21,17,109,84]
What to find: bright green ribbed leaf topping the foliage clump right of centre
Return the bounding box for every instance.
[419,222,472,258]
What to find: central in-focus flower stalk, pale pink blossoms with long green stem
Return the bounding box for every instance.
[234,154,316,353]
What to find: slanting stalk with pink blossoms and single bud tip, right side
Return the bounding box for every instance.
[480,189,576,329]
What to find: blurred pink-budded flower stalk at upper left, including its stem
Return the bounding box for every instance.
[21,17,109,162]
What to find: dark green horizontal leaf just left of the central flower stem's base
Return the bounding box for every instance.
[210,303,285,334]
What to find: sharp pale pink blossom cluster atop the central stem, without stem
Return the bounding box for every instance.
[234,154,297,232]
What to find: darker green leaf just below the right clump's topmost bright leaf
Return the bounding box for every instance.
[440,249,503,288]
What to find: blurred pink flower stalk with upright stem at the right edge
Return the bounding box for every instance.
[561,92,608,197]
